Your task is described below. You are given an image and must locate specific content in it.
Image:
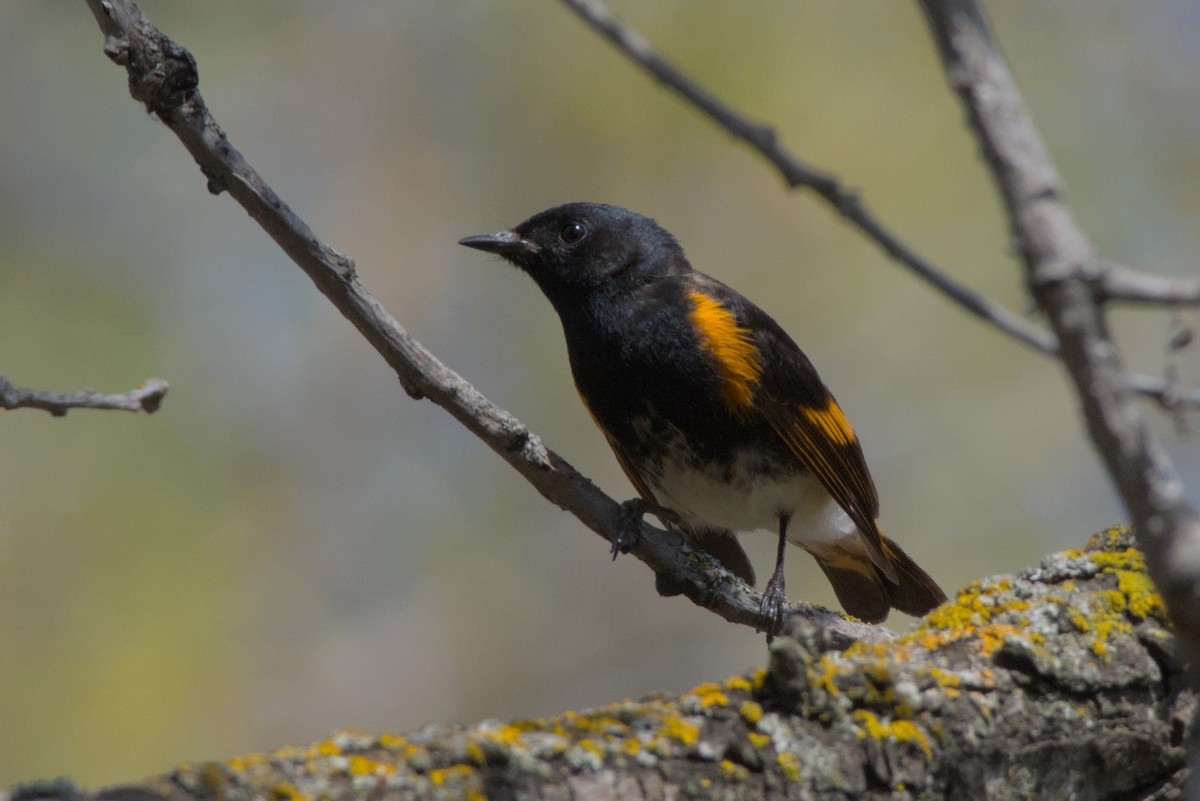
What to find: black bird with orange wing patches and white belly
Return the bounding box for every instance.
[460,203,946,633]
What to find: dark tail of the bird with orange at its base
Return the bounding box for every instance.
[809,537,946,624]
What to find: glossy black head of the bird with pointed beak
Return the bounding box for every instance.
[458,203,688,306]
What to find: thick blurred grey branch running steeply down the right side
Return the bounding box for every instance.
[920,0,1200,759]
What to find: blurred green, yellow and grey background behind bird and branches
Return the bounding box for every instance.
[0,0,1200,787]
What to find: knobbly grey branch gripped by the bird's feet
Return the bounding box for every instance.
[88,0,890,645]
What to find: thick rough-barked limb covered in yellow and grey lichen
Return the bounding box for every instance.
[7,530,1195,801]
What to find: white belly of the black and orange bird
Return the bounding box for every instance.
[650,448,858,547]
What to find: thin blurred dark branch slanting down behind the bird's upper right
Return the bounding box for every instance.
[563,0,1058,356]
